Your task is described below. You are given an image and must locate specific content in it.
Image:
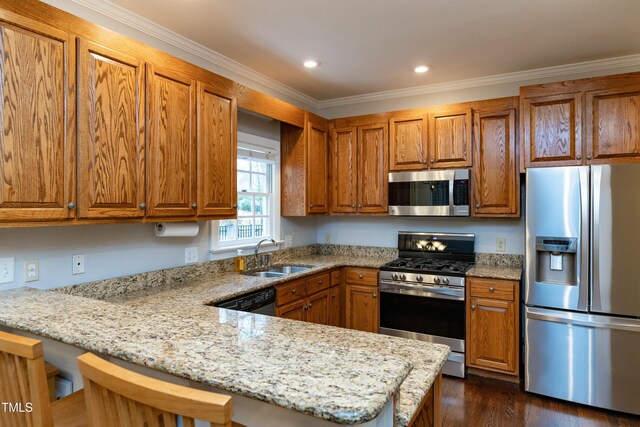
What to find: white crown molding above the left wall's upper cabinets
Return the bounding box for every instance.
[71,0,318,109]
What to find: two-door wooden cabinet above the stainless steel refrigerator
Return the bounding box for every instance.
[520,73,640,168]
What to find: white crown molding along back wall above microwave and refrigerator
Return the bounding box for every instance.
[317,55,640,109]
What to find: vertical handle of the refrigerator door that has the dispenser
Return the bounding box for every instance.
[577,167,591,311]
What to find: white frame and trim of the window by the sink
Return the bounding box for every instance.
[209,132,282,253]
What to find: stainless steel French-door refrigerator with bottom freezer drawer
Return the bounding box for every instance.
[524,164,640,414]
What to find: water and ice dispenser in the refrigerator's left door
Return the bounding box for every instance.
[536,236,578,285]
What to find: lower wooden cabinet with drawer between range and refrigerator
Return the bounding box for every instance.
[466,277,520,376]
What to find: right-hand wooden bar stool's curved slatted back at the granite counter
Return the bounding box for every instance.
[78,353,243,427]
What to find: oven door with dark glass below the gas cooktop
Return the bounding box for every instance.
[380,282,465,353]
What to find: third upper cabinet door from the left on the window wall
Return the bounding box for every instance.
[147,65,197,217]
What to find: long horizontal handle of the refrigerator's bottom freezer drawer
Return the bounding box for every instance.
[526,307,640,332]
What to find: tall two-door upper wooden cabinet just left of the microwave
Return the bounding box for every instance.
[331,123,388,214]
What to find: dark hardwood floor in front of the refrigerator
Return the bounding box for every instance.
[442,375,640,427]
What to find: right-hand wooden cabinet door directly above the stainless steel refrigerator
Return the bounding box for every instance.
[585,86,640,163]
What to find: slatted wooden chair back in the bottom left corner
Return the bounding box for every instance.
[0,332,53,427]
